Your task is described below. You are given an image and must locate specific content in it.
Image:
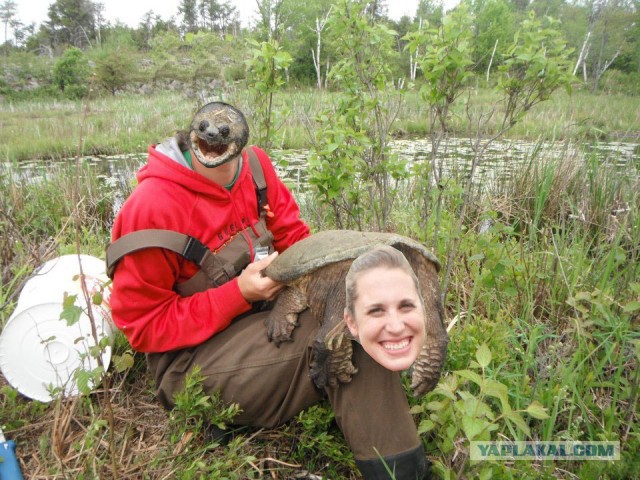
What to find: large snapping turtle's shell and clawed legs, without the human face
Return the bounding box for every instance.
[263,230,448,396]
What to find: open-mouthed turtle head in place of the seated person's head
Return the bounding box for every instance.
[189,102,249,168]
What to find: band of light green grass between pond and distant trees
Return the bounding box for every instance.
[0,88,640,161]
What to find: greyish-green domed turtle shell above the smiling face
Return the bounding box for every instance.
[264,230,440,283]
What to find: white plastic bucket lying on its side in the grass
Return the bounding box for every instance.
[0,255,114,402]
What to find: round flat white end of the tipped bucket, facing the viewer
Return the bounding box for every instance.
[0,303,112,402]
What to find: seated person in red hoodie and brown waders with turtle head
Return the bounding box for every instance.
[107,102,427,480]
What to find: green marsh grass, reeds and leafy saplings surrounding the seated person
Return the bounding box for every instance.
[0,2,640,479]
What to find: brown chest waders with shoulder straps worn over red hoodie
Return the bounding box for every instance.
[107,149,424,480]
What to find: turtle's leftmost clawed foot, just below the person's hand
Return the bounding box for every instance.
[265,287,308,346]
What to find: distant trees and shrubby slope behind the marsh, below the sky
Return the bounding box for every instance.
[0,0,640,96]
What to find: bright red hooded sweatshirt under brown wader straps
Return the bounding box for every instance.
[110,146,309,352]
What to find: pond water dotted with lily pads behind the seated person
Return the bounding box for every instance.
[5,138,640,190]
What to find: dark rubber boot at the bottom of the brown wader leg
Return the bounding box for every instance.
[356,445,431,480]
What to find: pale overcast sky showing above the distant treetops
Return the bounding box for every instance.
[14,0,418,27]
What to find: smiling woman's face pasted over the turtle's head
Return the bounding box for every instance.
[344,267,425,371]
